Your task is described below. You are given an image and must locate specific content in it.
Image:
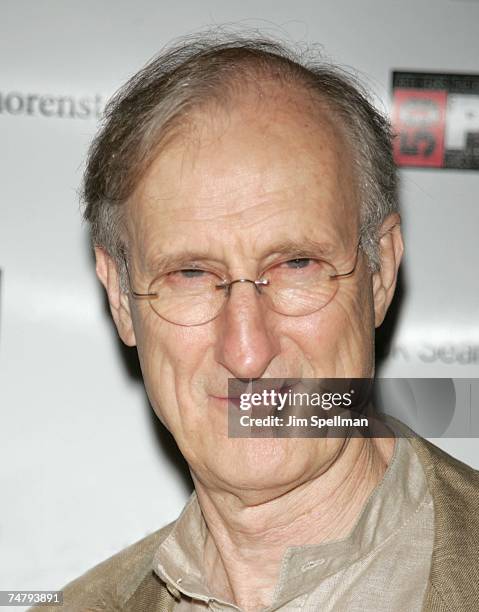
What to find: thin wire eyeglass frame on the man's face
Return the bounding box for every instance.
[122,237,361,327]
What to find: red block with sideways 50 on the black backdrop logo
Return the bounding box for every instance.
[393,88,447,168]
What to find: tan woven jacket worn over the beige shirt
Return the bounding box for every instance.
[29,438,479,612]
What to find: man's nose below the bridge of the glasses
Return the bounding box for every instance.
[215,282,280,378]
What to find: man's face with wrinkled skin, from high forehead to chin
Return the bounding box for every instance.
[107,86,392,498]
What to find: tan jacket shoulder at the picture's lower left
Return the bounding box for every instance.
[28,522,175,612]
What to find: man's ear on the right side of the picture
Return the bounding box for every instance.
[373,213,404,327]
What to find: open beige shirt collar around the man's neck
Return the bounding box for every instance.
[153,438,427,609]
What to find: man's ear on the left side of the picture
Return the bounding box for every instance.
[95,247,136,346]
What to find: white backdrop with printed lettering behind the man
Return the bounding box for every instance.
[0,0,479,604]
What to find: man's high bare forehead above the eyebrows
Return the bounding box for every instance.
[126,88,359,266]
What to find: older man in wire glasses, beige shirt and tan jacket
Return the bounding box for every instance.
[31,36,479,612]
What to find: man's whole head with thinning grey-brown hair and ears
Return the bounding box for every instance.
[84,33,402,500]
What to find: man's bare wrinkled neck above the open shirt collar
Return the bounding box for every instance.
[193,438,394,610]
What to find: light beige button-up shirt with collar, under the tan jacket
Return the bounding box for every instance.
[153,438,434,612]
